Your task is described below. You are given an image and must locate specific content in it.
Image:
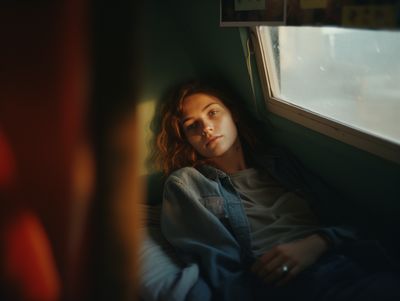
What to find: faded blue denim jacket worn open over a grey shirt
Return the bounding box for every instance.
[161,150,355,300]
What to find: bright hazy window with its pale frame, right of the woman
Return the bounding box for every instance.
[253,26,400,162]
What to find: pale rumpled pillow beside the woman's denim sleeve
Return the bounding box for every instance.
[139,206,211,301]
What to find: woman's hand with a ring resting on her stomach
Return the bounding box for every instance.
[251,234,328,286]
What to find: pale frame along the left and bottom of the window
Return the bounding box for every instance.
[249,27,400,164]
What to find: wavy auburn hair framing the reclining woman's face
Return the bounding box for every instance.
[151,81,270,176]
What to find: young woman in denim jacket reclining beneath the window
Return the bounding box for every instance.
[152,82,400,300]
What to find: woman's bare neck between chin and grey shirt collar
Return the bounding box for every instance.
[210,139,247,174]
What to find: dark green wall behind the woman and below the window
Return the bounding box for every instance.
[139,0,400,249]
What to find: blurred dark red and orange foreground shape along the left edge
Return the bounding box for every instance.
[0,0,140,301]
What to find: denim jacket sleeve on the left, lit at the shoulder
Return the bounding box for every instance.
[161,170,249,300]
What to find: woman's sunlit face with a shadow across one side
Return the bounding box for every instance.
[181,93,238,158]
